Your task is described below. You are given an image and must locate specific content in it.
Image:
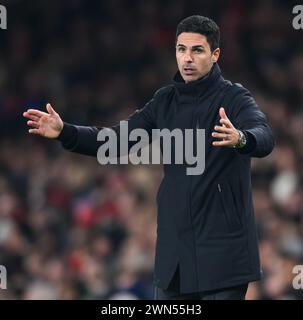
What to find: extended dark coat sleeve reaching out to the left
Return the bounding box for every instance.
[57,89,161,156]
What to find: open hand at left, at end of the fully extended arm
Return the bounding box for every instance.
[23,103,63,139]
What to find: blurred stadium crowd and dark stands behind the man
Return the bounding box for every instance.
[0,0,303,299]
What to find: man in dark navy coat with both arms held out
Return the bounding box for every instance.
[24,15,274,299]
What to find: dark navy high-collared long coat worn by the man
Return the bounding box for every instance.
[59,64,274,293]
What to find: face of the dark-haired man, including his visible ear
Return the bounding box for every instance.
[176,32,220,83]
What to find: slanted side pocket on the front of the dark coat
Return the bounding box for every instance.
[217,181,243,233]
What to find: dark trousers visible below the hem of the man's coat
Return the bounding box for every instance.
[154,268,248,300]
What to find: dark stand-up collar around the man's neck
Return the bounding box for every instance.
[173,63,221,96]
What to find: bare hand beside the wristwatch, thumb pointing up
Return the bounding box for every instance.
[212,107,240,147]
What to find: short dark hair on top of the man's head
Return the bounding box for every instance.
[176,15,220,51]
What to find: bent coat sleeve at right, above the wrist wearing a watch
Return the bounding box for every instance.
[231,87,275,158]
